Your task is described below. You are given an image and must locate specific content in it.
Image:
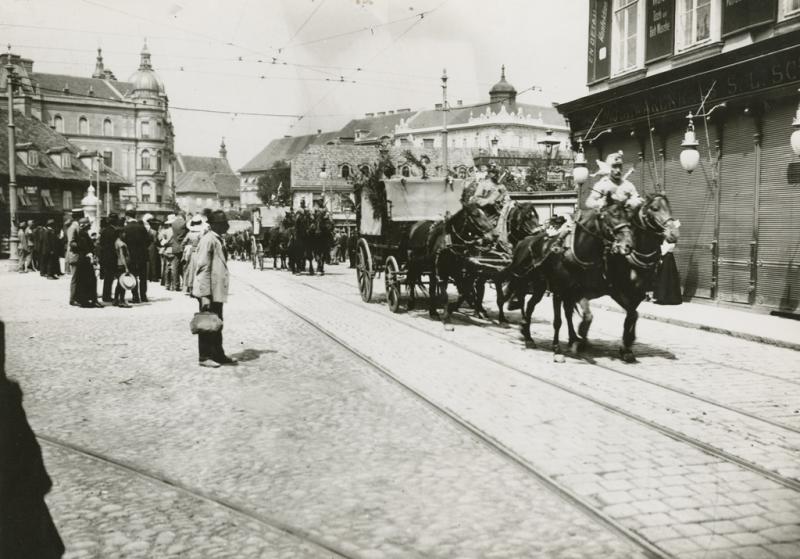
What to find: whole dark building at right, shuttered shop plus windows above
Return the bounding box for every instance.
[558,0,800,313]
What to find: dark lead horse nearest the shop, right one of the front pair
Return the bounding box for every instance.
[553,194,680,363]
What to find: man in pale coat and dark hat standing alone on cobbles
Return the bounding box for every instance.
[192,210,237,367]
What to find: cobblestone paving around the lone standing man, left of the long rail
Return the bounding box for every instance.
[0,270,644,558]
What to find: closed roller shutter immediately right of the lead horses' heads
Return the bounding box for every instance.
[659,123,716,300]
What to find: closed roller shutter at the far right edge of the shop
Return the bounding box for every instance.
[756,100,800,311]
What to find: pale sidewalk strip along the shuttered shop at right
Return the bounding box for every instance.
[592,297,800,350]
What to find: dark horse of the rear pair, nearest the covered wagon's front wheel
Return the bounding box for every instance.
[407,203,497,326]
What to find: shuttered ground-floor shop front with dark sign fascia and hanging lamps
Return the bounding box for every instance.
[558,31,800,313]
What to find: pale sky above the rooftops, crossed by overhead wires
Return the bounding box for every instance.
[0,0,589,169]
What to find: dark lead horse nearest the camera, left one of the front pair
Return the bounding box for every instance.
[496,205,633,355]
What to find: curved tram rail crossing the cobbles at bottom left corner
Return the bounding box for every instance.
[36,434,358,559]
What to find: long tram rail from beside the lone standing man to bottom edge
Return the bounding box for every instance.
[237,276,672,559]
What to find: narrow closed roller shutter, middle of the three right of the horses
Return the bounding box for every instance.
[718,113,756,303]
